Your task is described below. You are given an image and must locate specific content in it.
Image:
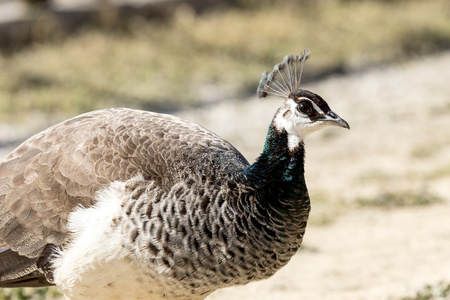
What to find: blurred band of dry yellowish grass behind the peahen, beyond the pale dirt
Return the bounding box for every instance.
[0,0,450,121]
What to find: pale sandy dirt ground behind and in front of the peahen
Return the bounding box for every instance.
[0,53,450,300]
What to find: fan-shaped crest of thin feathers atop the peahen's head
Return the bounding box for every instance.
[257,49,309,99]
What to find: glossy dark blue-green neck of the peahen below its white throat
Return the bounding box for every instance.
[238,124,310,227]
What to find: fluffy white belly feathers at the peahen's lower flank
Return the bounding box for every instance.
[53,177,190,299]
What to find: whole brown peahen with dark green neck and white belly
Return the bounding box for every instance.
[0,53,348,299]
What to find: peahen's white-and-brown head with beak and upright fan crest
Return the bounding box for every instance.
[257,50,350,150]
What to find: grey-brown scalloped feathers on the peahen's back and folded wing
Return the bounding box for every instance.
[0,108,248,257]
